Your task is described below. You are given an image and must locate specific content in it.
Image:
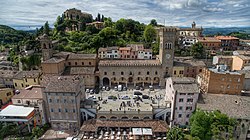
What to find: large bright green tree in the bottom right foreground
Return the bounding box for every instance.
[190,110,236,140]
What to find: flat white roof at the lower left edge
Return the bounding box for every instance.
[0,105,35,117]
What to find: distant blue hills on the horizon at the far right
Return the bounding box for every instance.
[203,27,250,35]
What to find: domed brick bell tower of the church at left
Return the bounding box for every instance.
[40,34,53,61]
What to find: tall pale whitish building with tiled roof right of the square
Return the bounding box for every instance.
[165,77,199,127]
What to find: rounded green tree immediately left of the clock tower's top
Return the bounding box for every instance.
[143,25,156,47]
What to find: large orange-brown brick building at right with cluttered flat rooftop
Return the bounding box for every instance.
[197,65,245,95]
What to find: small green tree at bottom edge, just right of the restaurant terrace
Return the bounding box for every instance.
[167,127,184,140]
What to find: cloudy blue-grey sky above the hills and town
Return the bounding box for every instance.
[0,0,250,29]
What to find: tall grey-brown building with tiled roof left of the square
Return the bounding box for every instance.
[42,76,85,130]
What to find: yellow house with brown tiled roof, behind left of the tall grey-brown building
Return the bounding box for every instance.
[13,71,41,89]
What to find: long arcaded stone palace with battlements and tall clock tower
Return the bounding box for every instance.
[98,27,177,87]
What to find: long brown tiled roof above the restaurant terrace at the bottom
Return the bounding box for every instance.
[81,119,169,132]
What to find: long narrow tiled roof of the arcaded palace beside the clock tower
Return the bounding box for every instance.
[99,60,161,66]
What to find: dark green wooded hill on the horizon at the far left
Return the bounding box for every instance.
[0,25,30,44]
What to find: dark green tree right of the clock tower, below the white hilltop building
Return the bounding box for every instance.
[191,42,205,59]
